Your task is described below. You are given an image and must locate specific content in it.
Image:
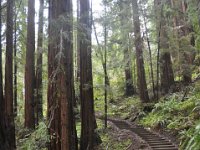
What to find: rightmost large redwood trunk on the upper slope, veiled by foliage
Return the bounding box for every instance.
[171,0,197,85]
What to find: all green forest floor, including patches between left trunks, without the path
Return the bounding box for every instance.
[16,80,200,150]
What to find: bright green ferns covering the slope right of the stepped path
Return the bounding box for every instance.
[140,86,200,150]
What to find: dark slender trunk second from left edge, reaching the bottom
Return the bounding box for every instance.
[5,0,16,150]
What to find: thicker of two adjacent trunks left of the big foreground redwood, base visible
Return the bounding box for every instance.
[25,0,35,129]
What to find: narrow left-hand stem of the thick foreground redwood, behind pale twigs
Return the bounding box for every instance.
[47,0,61,150]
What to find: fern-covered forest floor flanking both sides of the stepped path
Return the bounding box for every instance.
[95,81,200,150]
